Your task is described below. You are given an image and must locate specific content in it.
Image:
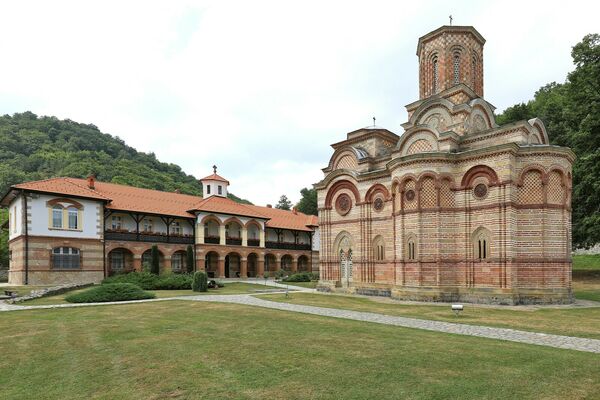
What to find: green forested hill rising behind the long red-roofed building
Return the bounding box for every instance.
[0,112,249,203]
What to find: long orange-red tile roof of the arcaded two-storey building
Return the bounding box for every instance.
[5,175,318,231]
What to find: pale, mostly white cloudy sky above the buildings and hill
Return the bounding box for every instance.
[0,0,600,205]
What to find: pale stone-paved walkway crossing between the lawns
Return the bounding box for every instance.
[0,282,600,354]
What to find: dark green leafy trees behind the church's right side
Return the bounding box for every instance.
[497,34,600,248]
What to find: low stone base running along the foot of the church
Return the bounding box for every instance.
[317,281,573,305]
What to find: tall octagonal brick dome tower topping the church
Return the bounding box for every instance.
[417,25,485,99]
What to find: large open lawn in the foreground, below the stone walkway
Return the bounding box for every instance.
[0,301,600,400]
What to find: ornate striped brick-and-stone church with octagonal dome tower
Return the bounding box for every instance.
[315,26,575,304]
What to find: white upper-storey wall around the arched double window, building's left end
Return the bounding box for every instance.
[27,194,103,239]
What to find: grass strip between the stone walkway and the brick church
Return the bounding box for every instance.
[259,293,600,339]
